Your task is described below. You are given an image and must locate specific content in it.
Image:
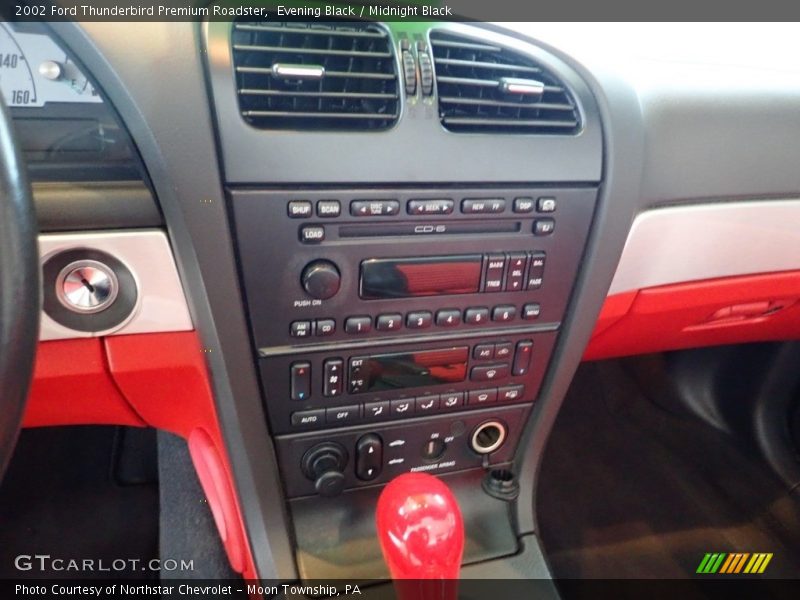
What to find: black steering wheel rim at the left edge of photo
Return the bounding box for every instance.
[0,97,42,481]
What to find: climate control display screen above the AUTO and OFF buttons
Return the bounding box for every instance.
[350,346,469,393]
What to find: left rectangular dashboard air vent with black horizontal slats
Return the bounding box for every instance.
[232,21,400,131]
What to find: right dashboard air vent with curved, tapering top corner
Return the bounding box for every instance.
[431,31,580,135]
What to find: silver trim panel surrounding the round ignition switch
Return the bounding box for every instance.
[39,230,194,341]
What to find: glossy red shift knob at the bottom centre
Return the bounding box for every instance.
[376,473,464,600]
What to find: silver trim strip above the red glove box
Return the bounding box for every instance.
[608,199,800,294]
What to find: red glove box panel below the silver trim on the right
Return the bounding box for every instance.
[584,271,800,360]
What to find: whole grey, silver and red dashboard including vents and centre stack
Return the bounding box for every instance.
[9,19,800,580]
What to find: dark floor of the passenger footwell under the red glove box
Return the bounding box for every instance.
[537,361,800,578]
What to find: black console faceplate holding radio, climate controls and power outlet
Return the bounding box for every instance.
[231,186,596,498]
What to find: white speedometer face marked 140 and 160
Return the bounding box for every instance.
[0,24,102,107]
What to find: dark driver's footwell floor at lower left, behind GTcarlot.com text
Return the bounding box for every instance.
[0,427,158,579]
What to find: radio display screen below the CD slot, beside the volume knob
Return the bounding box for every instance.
[359,254,482,300]
